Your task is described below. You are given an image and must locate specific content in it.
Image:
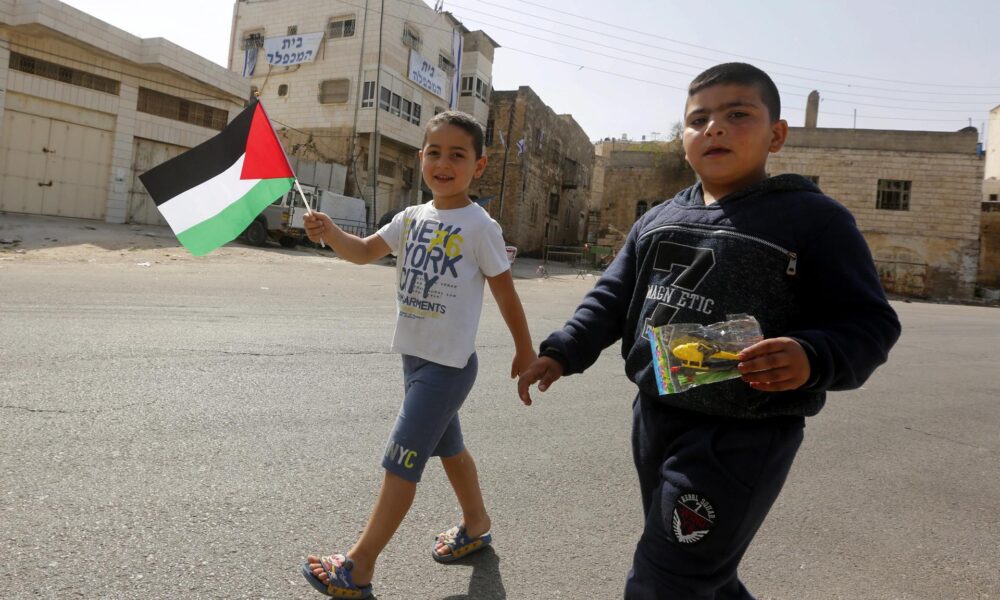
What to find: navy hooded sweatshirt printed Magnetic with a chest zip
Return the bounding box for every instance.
[540,175,900,418]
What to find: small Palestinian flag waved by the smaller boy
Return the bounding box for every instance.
[139,101,295,256]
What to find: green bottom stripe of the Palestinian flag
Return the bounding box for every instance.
[177,178,295,256]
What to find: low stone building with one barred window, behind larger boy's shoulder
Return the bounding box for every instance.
[768,127,983,298]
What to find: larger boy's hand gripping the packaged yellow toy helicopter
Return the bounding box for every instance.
[737,338,811,392]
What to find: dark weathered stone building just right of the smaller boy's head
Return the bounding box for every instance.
[471,86,594,254]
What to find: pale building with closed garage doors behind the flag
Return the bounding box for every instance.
[0,0,249,224]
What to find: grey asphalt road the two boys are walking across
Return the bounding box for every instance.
[0,250,1000,600]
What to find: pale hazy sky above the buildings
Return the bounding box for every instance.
[63,0,1000,139]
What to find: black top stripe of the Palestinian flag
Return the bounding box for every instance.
[139,102,257,205]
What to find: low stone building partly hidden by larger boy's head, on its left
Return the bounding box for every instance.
[590,139,696,249]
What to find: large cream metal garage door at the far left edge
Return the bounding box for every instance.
[0,110,112,219]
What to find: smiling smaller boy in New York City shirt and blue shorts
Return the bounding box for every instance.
[302,112,536,598]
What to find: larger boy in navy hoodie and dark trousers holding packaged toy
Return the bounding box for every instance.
[518,63,900,600]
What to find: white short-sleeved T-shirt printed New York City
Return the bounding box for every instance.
[378,201,510,368]
